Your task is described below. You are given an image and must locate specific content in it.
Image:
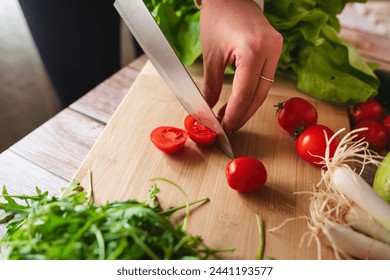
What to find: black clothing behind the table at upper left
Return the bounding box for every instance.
[19,0,120,107]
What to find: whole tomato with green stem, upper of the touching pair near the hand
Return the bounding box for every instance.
[276,97,318,136]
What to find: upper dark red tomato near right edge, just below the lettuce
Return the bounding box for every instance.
[348,98,384,124]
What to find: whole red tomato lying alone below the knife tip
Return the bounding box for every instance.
[226,157,267,193]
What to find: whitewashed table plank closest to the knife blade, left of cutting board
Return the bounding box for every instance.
[70,65,141,123]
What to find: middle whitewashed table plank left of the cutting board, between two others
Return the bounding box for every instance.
[9,109,103,180]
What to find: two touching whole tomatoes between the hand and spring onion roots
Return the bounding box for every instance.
[276,97,340,167]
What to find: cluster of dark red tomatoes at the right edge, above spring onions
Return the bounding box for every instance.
[348,98,390,153]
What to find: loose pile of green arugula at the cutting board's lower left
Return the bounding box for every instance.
[0,181,227,260]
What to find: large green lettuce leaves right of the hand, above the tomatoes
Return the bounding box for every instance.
[264,0,379,104]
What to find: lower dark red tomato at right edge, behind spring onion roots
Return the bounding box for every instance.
[355,121,387,153]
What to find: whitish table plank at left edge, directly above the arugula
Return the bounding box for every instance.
[0,150,68,195]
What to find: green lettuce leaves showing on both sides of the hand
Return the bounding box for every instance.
[145,0,379,104]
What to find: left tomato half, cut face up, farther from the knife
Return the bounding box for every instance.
[150,126,188,154]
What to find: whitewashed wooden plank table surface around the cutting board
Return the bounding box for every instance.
[0,29,390,249]
